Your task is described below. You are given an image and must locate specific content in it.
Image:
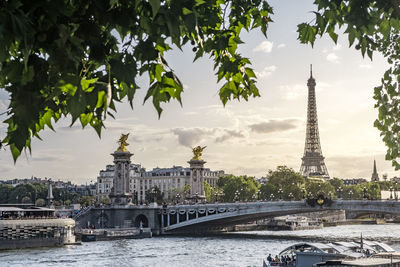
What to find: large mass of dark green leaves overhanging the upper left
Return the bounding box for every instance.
[0,0,272,161]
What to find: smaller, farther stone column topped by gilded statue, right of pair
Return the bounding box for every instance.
[188,146,206,202]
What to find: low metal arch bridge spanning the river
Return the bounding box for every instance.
[160,200,400,233]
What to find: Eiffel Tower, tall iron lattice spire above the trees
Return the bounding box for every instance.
[300,65,329,179]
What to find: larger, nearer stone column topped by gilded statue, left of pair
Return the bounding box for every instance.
[110,134,133,205]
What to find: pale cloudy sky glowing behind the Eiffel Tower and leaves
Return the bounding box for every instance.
[0,0,398,183]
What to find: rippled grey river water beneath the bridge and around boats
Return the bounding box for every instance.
[0,224,400,267]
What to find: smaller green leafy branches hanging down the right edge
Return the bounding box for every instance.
[298,0,400,170]
